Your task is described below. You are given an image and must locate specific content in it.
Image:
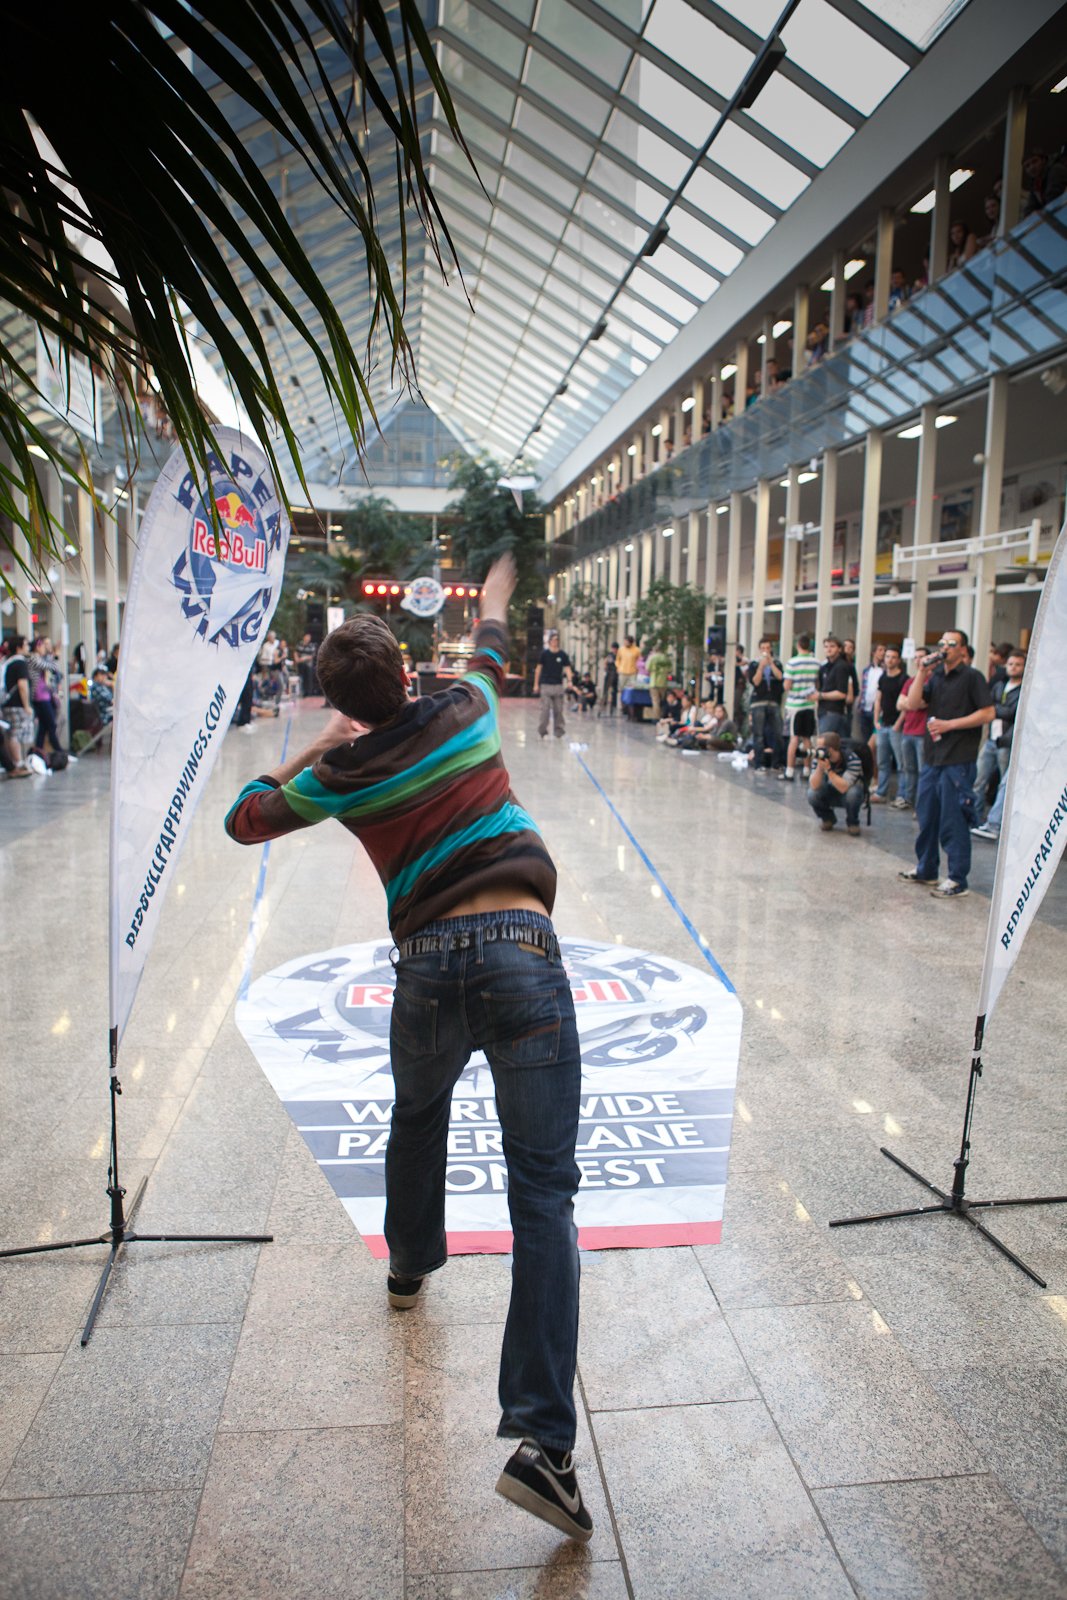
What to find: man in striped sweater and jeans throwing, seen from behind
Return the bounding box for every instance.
[226,557,592,1541]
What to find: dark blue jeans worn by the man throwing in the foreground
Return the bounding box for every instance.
[386,910,582,1451]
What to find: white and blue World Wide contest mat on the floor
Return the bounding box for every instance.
[237,939,741,1258]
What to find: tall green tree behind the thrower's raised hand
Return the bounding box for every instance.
[448,454,545,640]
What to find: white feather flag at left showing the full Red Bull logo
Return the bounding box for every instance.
[109,427,290,1072]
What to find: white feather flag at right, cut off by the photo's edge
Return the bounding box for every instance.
[977,528,1067,1024]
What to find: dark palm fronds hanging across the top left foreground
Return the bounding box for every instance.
[0,0,466,585]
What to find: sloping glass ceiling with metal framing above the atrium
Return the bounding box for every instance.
[195,0,966,482]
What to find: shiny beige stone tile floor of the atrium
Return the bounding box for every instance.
[0,702,1067,1600]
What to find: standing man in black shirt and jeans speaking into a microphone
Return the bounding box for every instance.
[901,627,993,899]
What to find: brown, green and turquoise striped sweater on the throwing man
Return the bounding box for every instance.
[226,621,555,939]
